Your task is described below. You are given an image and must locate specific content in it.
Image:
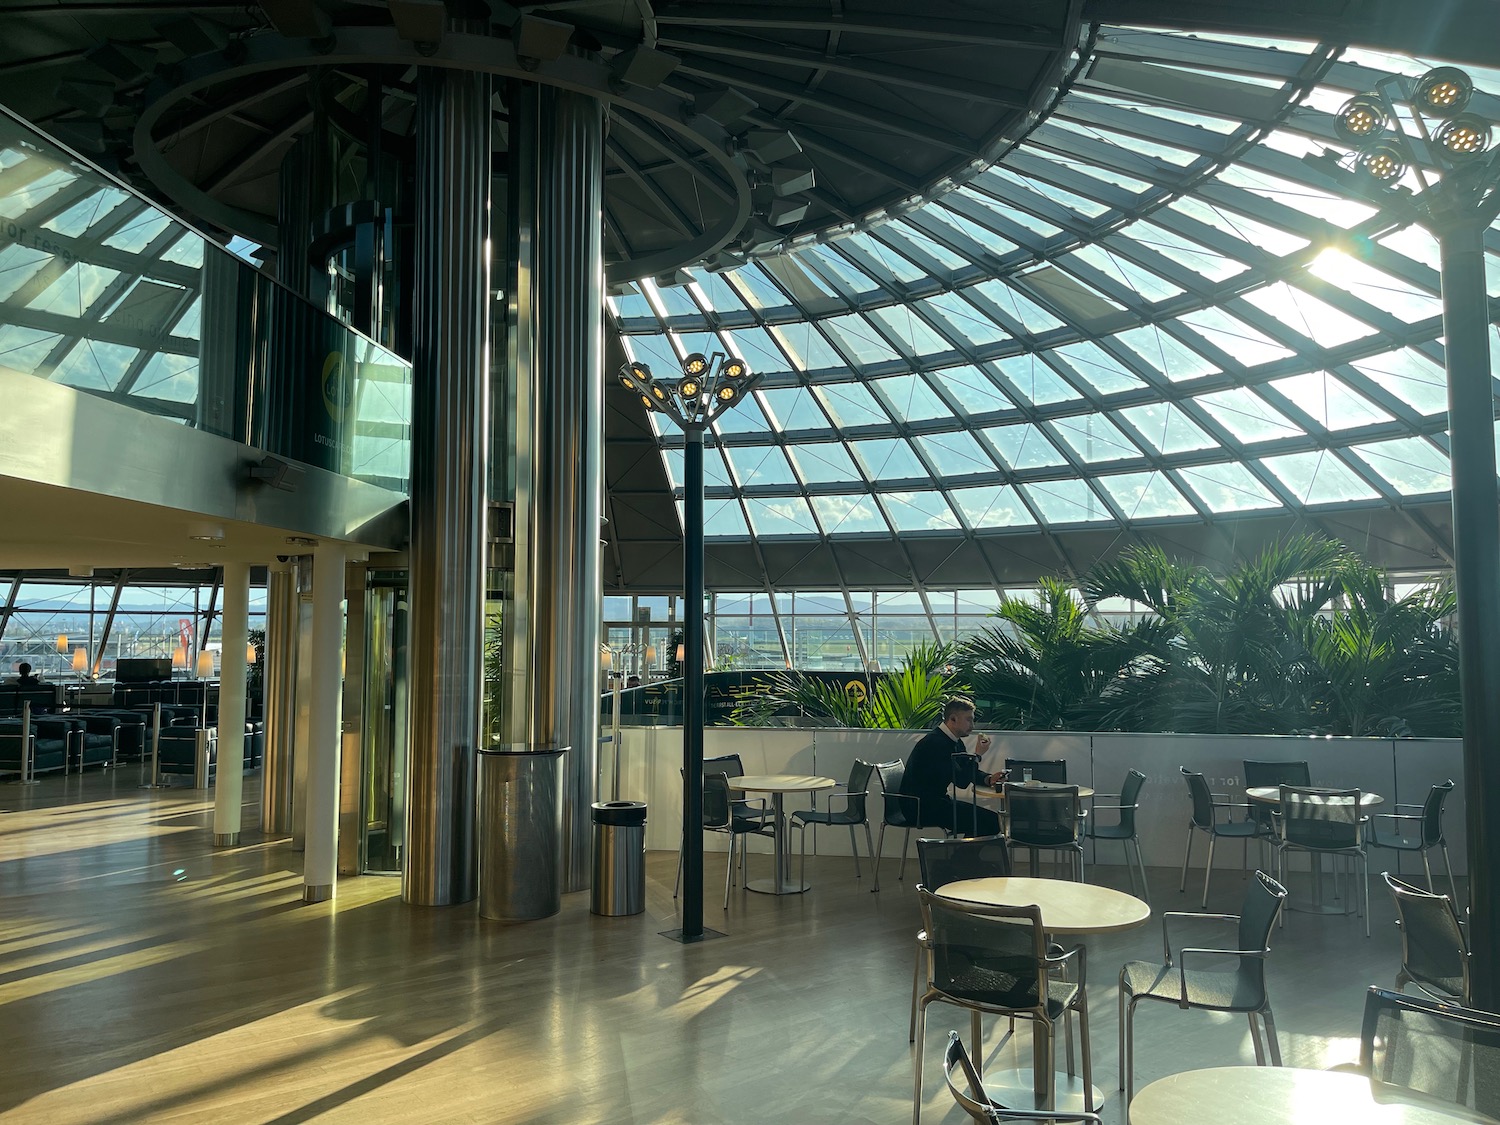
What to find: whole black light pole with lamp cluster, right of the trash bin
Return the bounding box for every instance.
[620,351,756,942]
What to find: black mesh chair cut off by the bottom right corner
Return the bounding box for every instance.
[1359,989,1500,1122]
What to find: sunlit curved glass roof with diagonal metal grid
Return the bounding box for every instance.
[611,27,1500,564]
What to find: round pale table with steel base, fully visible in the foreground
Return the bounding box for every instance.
[938,876,1146,1121]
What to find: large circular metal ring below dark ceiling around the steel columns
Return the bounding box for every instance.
[134,27,752,284]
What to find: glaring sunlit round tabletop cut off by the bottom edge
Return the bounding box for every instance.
[1130,1067,1473,1125]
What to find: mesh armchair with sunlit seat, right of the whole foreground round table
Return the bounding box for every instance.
[1119,872,1287,1113]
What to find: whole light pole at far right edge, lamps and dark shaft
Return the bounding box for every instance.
[1307,66,1500,1011]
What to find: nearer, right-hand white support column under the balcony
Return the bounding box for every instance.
[302,543,345,903]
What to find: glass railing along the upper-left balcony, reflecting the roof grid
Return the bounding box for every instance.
[0,111,411,494]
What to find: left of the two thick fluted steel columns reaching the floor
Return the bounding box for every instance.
[402,61,491,906]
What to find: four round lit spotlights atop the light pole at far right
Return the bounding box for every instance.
[1334,66,1491,186]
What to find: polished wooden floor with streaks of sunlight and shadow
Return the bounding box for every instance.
[0,767,1428,1125]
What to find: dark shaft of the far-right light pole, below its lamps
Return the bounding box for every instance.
[1439,222,1500,1011]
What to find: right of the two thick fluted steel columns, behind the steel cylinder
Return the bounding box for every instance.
[504,83,605,891]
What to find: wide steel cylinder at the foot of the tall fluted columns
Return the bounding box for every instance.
[479,744,567,923]
